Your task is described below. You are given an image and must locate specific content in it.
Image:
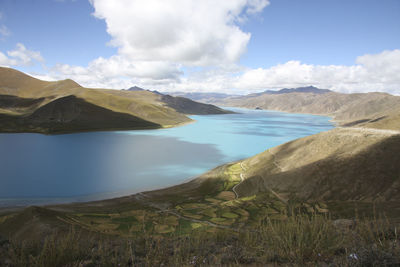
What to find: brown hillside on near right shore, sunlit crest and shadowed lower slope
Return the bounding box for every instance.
[237,128,400,201]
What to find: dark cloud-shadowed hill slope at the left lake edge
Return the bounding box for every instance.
[0,96,160,134]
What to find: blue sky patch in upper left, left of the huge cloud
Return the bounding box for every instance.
[0,0,117,66]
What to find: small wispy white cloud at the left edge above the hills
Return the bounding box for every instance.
[0,43,44,67]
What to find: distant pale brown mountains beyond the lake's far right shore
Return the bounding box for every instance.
[209,87,400,124]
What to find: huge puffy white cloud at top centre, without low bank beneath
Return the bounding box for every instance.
[91,0,269,66]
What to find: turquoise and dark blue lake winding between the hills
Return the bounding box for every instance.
[0,109,333,207]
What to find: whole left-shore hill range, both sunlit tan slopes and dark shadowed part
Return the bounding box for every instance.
[0,67,230,133]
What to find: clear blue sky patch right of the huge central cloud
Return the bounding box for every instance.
[241,0,400,67]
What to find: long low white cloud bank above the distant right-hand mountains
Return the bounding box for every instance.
[233,50,400,94]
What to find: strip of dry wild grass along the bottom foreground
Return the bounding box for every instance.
[0,215,400,266]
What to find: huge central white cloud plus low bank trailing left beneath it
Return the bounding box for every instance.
[25,0,269,89]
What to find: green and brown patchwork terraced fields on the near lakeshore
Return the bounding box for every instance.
[48,162,328,237]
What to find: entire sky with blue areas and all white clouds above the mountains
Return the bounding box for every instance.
[0,0,400,95]
